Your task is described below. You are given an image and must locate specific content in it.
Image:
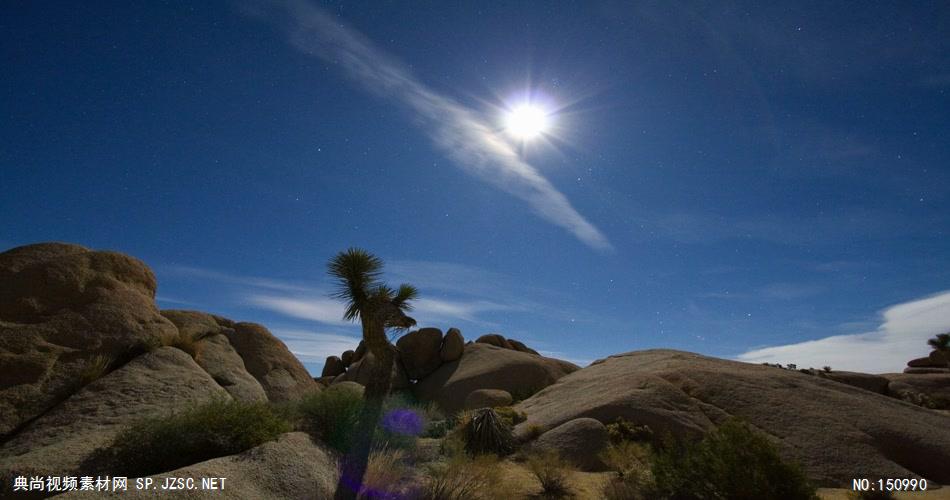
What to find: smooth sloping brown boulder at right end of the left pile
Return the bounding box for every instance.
[226,323,320,402]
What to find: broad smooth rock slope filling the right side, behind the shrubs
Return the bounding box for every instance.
[516,350,950,487]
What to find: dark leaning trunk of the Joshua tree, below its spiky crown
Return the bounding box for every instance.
[334,317,395,500]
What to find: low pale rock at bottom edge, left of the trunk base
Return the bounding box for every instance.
[57,432,338,500]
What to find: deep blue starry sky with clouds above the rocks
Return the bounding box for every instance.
[0,1,950,371]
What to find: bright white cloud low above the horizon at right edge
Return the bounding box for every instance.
[738,291,950,373]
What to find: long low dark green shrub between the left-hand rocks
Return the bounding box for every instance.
[102,399,290,477]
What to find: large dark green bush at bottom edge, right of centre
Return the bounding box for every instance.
[650,420,817,500]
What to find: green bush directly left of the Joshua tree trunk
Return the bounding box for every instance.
[297,387,363,452]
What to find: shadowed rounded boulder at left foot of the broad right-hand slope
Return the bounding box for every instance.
[530,418,608,471]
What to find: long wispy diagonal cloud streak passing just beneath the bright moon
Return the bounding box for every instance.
[247,0,613,251]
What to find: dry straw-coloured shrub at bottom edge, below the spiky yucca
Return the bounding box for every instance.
[419,454,504,500]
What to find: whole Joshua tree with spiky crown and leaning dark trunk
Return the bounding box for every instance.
[328,248,419,500]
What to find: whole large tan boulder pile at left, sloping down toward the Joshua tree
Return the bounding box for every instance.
[0,243,320,478]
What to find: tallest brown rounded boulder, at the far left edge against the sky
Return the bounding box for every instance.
[0,243,178,436]
